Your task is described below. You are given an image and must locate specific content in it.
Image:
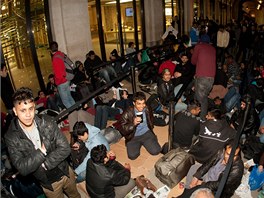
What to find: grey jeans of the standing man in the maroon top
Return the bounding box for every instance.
[194,77,214,120]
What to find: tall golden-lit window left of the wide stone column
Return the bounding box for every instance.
[1,0,51,96]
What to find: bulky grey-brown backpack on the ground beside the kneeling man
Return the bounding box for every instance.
[154,148,195,188]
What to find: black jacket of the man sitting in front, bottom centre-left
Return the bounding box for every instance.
[86,159,131,198]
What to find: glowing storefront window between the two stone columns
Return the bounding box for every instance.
[88,0,142,59]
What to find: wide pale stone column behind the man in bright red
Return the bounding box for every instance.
[49,0,93,62]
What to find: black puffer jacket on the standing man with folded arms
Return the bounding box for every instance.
[5,115,71,190]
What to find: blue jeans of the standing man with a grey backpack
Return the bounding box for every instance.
[57,81,75,109]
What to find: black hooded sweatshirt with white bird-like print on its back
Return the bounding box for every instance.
[189,119,236,164]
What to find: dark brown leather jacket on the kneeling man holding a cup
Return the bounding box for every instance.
[117,106,154,143]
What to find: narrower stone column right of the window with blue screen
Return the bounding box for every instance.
[144,0,164,47]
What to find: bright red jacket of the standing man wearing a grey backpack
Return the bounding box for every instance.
[52,51,67,86]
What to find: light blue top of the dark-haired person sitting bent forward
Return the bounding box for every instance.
[75,123,110,175]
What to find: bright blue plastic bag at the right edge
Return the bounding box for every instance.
[248,165,264,190]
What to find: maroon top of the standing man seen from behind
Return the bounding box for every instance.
[192,43,216,77]
